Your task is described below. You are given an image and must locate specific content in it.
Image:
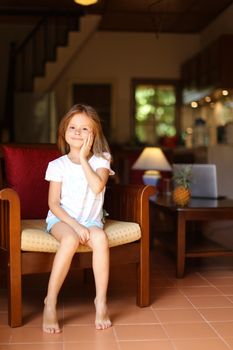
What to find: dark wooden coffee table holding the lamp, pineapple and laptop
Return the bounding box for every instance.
[150,195,233,278]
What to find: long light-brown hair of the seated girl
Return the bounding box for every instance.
[57,104,110,158]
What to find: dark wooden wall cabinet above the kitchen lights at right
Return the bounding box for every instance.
[181,35,233,89]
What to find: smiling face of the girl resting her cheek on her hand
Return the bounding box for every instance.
[65,113,94,148]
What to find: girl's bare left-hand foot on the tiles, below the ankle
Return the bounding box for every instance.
[43,299,61,334]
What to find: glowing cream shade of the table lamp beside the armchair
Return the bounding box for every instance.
[132,147,172,171]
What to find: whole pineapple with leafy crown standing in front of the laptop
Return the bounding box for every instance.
[172,165,192,207]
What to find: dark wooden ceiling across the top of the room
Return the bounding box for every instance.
[0,0,233,33]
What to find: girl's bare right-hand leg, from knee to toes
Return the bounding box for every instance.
[88,227,111,329]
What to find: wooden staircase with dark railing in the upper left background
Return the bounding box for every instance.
[4,13,100,142]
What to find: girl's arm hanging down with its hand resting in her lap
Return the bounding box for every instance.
[48,181,90,243]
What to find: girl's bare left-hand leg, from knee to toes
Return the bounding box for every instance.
[43,222,79,333]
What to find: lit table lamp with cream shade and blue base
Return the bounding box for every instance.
[132,147,172,186]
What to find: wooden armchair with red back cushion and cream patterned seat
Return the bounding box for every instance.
[0,145,154,327]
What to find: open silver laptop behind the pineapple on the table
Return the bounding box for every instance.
[173,164,222,199]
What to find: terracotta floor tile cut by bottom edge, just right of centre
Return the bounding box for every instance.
[119,340,174,350]
